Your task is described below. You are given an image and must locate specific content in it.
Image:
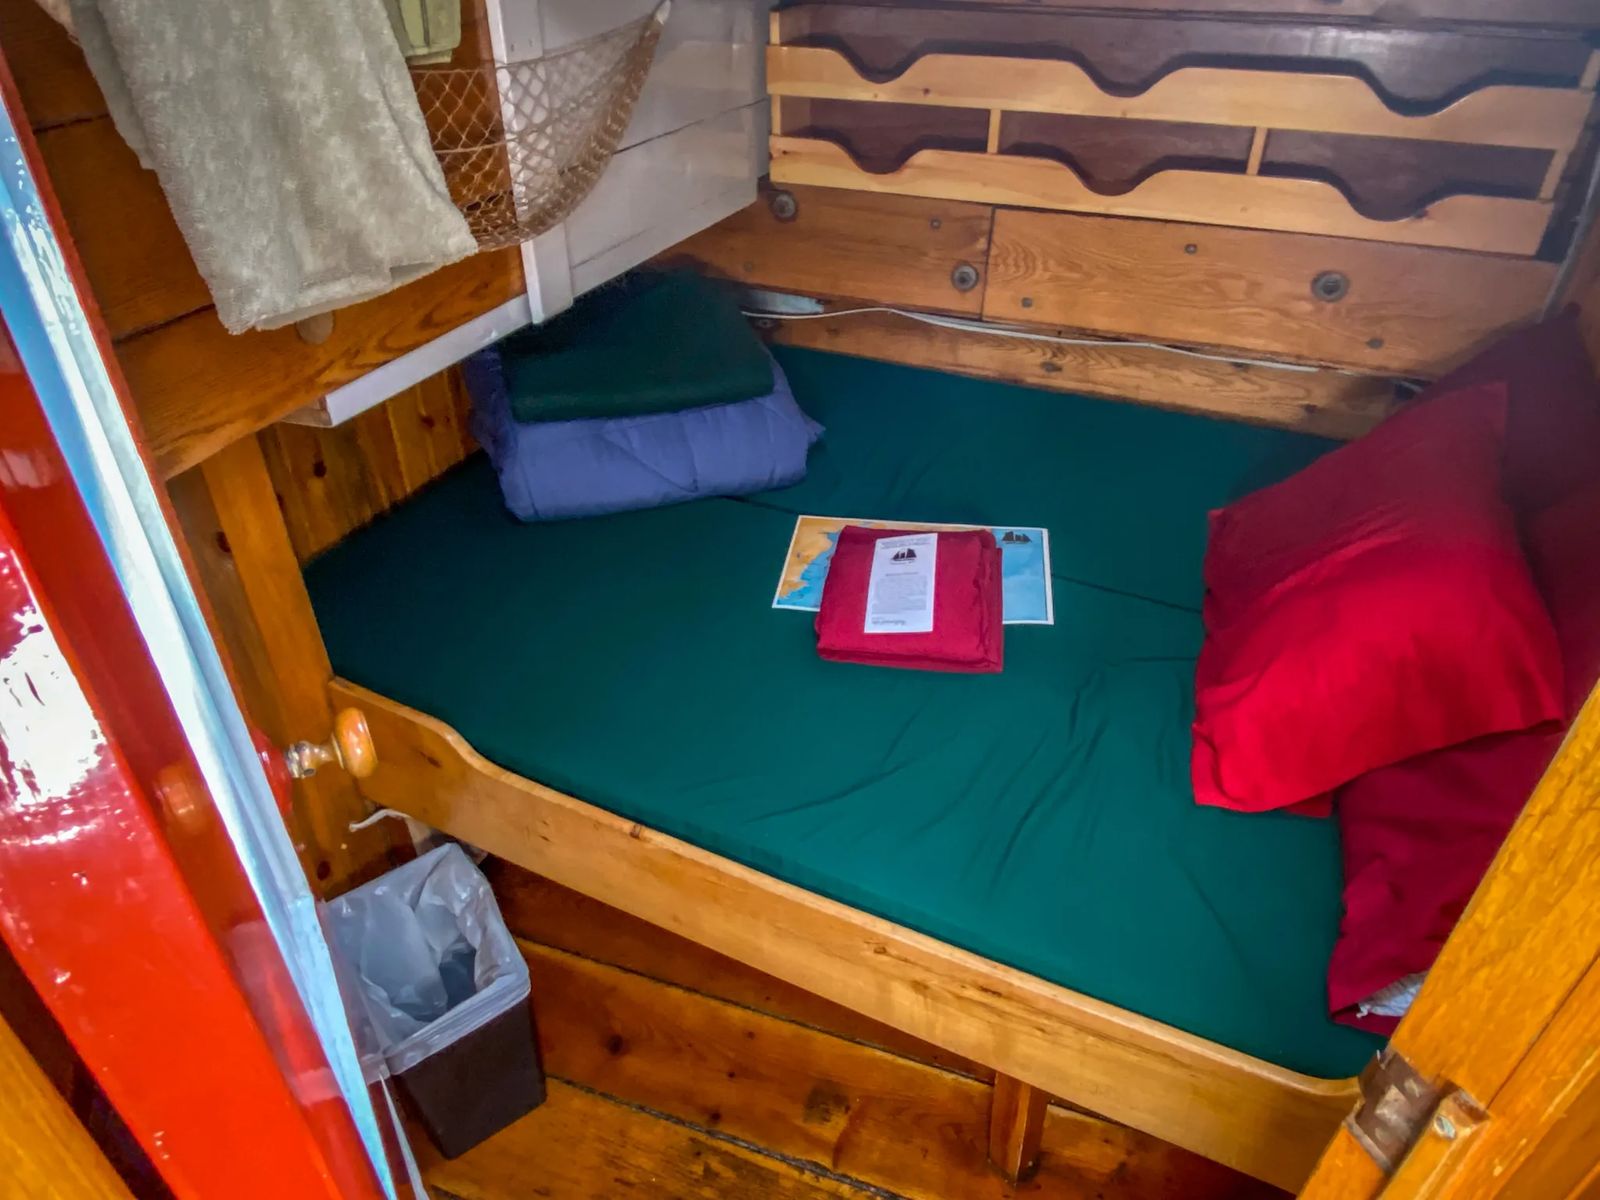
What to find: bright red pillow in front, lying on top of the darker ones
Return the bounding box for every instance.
[1192,386,1562,811]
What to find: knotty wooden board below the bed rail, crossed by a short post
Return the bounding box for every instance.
[522,942,1274,1200]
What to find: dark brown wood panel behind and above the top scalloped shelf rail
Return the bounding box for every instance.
[774,0,1594,106]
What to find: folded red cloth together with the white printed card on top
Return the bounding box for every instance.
[816,525,1003,672]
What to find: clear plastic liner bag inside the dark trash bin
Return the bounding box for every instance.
[323,845,528,1078]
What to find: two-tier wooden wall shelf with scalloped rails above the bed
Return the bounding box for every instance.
[766,5,1595,256]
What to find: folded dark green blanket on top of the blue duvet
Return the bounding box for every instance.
[504,272,773,422]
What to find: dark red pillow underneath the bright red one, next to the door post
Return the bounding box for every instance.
[1328,480,1600,1034]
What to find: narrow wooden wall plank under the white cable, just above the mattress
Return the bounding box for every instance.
[773,314,1394,438]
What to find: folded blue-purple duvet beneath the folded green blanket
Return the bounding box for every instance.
[462,346,822,522]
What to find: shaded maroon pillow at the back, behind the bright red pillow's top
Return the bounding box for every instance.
[1422,307,1600,514]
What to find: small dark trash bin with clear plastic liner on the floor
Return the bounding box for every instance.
[325,845,544,1158]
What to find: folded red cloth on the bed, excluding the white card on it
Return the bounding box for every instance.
[816,525,1005,672]
